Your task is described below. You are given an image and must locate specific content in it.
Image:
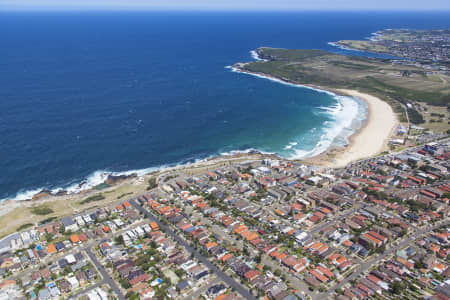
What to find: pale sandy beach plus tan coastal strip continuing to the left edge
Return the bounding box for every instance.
[0,83,398,236]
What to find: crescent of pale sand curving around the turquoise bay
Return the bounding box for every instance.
[307,89,399,168]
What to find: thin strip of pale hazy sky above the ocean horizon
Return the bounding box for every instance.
[0,0,450,11]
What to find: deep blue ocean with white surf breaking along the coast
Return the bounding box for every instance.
[0,12,450,199]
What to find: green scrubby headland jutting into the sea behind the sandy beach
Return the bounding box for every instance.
[235,48,450,114]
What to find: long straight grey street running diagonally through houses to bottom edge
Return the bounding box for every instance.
[130,200,256,300]
